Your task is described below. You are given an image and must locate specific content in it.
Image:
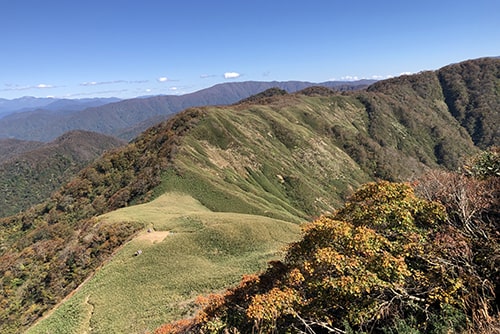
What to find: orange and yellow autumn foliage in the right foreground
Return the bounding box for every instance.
[157,182,498,333]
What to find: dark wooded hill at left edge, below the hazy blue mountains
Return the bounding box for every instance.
[0,131,125,217]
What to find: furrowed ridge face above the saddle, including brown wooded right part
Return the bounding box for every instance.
[158,88,477,219]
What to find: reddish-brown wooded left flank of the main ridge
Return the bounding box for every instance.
[0,109,207,333]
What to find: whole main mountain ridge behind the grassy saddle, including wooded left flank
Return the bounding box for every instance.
[0,58,500,333]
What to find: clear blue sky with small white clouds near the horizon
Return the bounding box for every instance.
[0,0,500,99]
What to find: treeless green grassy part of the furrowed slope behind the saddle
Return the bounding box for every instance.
[158,96,376,221]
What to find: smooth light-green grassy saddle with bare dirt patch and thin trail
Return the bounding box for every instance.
[28,193,299,333]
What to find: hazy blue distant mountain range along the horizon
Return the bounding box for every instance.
[0,80,374,142]
